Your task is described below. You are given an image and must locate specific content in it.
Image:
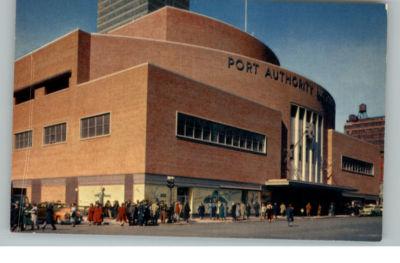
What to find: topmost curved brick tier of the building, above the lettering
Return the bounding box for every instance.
[108,7,278,63]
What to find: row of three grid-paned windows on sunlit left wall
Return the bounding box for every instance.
[14,113,110,149]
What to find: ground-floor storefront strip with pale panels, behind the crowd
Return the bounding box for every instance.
[13,174,377,215]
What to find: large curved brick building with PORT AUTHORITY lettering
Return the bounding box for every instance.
[12,7,379,216]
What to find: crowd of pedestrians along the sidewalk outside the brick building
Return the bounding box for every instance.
[10,197,342,231]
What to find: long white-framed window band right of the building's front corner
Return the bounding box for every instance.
[177,113,267,154]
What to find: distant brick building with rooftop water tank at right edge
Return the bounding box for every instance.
[344,104,385,153]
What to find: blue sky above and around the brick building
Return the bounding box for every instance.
[15,0,387,131]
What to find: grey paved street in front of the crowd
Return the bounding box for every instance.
[18,217,382,241]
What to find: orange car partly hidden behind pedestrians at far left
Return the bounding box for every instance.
[38,203,82,224]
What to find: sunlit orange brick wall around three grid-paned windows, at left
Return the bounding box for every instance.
[13,65,147,180]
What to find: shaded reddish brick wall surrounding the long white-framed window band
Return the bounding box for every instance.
[146,66,281,184]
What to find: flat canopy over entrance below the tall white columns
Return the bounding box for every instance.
[265,179,357,192]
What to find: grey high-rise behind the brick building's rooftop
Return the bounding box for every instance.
[97,0,189,33]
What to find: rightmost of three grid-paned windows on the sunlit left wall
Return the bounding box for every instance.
[81,113,110,138]
